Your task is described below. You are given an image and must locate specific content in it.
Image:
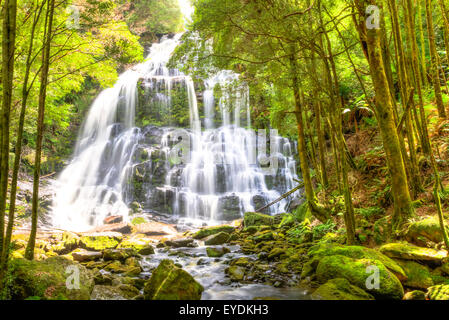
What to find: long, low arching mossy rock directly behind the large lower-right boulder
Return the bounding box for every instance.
[309,243,407,281]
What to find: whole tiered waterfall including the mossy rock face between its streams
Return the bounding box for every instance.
[53,35,297,231]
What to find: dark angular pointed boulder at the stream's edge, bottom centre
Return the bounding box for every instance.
[144,260,204,300]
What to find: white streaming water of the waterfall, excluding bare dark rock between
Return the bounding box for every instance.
[53,35,297,231]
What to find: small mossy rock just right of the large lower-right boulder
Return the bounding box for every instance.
[396,260,434,289]
